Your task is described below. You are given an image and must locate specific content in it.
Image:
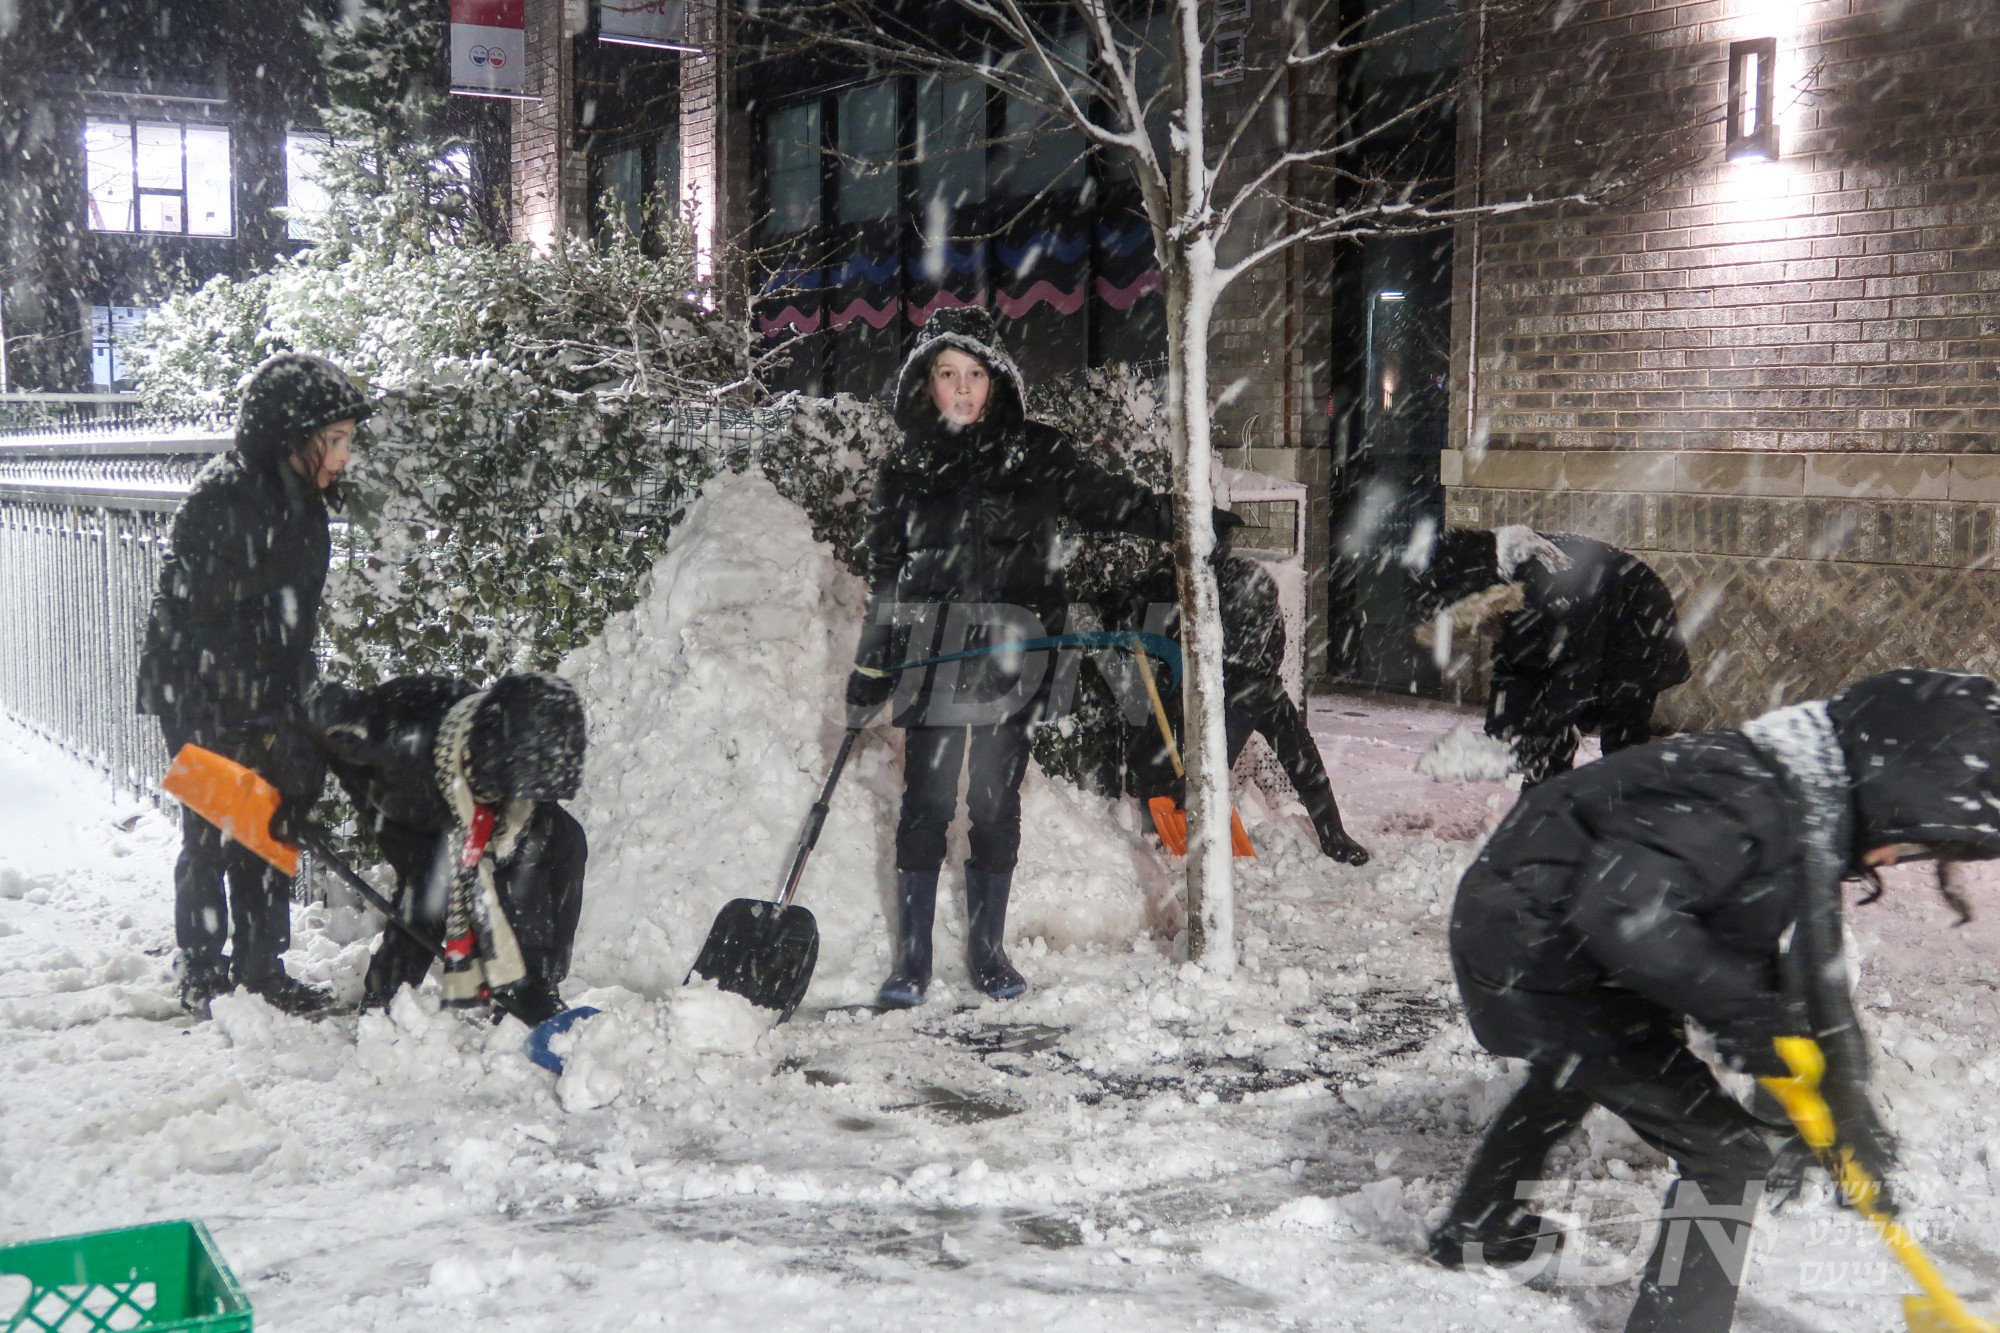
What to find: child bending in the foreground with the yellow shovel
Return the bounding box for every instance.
[1430,669,2000,1333]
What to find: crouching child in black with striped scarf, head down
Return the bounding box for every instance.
[308,675,588,1027]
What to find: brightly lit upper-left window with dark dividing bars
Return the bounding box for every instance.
[84,120,236,236]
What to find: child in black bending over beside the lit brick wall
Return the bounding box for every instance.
[1418,526,1690,787]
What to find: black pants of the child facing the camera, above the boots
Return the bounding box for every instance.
[896,721,1028,875]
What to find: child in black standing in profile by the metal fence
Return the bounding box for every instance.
[138,352,370,1015]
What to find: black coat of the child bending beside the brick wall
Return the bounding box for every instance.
[1486,532,1690,739]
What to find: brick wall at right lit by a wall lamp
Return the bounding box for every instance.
[1444,0,2000,725]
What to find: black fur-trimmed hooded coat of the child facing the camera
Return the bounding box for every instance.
[856,306,1174,725]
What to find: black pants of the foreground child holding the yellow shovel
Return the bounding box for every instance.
[1450,1039,1772,1333]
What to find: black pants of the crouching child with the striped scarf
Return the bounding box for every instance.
[366,803,590,1001]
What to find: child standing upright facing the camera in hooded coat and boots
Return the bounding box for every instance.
[846,306,1216,1007]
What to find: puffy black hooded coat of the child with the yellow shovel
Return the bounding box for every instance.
[1452,671,2000,1061]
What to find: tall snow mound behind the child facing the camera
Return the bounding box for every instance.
[564,474,1178,1005]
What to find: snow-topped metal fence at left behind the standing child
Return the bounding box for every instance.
[0,420,230,797]
